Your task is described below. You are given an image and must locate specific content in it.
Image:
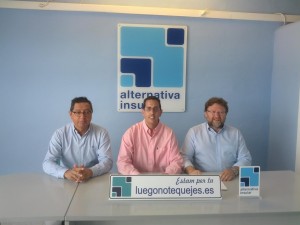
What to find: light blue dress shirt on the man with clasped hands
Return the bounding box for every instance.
[43,123,113,178]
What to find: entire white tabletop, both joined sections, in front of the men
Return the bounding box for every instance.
[0,171,300,225]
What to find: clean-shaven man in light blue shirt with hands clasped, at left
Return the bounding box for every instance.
[43,97,113,182]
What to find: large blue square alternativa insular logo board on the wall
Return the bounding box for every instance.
[118,24,187,112]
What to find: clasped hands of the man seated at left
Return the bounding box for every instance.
[64,165,93,183]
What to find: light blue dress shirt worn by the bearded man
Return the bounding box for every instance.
[181,123,252,172]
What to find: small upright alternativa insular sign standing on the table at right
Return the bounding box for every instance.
[239,166,260,197]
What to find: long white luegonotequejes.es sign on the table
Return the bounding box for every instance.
[109,175,222,200]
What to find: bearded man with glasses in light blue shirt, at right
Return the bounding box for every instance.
[181,97,252,181]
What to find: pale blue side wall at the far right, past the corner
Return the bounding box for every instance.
[268,22,300,170]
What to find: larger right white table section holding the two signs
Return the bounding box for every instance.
[66,171,300,221]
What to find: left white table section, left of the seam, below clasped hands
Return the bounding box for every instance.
[0,173,77,222]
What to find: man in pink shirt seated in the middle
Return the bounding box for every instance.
[117,96,183,175]
